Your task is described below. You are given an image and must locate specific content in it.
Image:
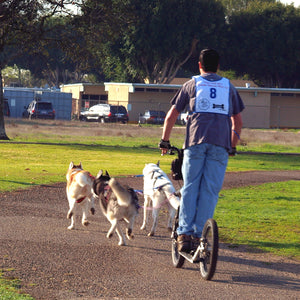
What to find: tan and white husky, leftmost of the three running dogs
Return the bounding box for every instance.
[66,162,95,229]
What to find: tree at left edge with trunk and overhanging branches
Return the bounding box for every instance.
[0,0,78,140]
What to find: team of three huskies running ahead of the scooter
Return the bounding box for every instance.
[66,162,180,246]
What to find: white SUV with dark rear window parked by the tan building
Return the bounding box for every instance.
[79,104,128,124]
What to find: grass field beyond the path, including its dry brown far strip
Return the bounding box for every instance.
[0,119,300,190]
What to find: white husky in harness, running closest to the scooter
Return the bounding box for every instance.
[141,162,180,236]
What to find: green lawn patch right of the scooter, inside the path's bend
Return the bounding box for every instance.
[215,180,300,259]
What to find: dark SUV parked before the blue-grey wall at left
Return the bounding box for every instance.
[22,100,55,120]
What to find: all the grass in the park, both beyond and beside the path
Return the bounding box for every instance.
[0,119,300,299]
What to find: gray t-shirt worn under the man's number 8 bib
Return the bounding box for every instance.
[171,73,245,149]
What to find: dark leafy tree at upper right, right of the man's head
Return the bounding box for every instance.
[225,2,300,88]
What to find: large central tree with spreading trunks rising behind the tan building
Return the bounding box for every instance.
[82,0,225,83]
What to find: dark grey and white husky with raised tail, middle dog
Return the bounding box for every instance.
[93,170,139,246]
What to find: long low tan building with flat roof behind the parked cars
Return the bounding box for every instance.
[61,81,300,128]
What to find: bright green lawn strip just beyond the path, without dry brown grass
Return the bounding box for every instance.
[0,143,300,191]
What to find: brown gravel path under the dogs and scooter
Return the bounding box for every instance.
[0,171,300,300]
